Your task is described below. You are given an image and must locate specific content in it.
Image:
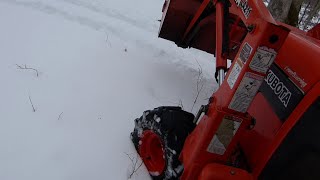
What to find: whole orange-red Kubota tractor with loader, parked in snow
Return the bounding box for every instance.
[131,0,320,180]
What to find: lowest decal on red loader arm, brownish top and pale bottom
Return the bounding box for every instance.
[207,116,242,155]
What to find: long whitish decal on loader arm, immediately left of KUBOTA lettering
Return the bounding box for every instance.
[229,73,263,113]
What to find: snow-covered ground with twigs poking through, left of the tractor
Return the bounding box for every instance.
[0,0,216,180]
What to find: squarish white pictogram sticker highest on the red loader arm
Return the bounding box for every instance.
[250,47,277,73]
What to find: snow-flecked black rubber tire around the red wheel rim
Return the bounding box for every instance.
[131,106,196,180]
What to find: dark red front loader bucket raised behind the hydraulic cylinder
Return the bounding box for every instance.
[159,0,248,59]
